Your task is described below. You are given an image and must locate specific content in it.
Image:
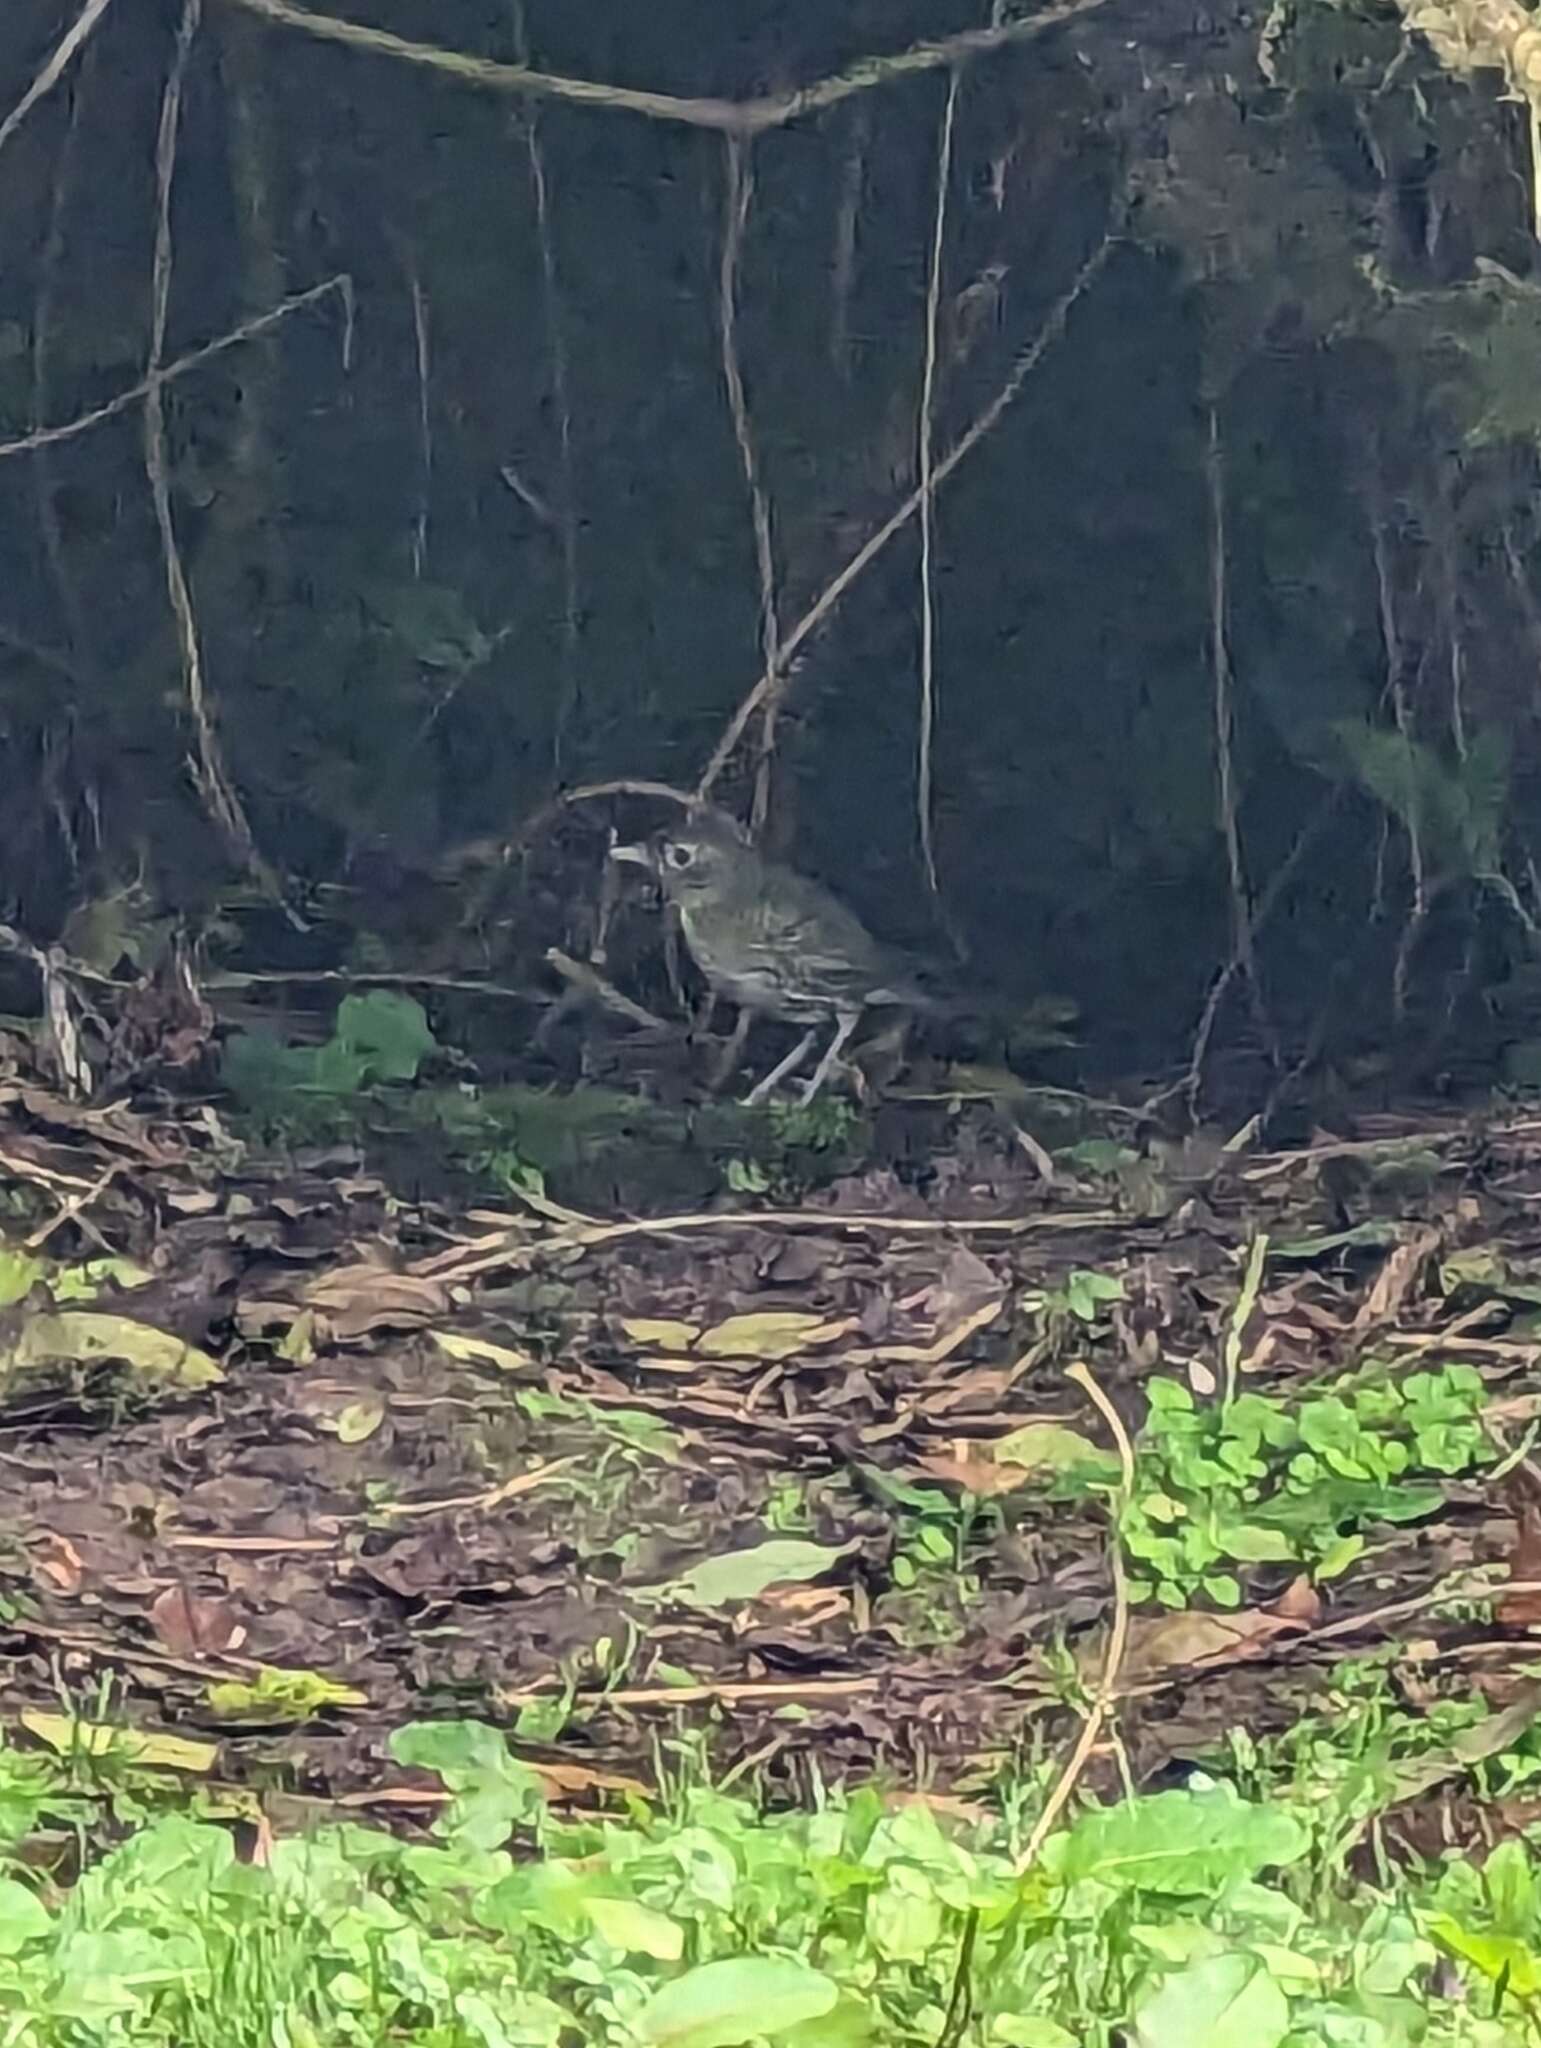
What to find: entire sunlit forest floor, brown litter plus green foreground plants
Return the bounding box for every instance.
[0,1056,1541,2048]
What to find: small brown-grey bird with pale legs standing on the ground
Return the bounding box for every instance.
[611,811,936,1104]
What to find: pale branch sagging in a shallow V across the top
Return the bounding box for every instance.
[214,0,1105,135]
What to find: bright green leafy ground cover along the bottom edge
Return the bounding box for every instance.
[0,1673,1541,2048]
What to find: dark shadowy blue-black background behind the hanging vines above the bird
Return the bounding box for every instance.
[0,0,1541,1071]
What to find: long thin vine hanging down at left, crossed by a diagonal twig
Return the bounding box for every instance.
[143,0,268,895]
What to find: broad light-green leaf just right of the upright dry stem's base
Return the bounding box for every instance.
[1045,1784,1309,1894]
